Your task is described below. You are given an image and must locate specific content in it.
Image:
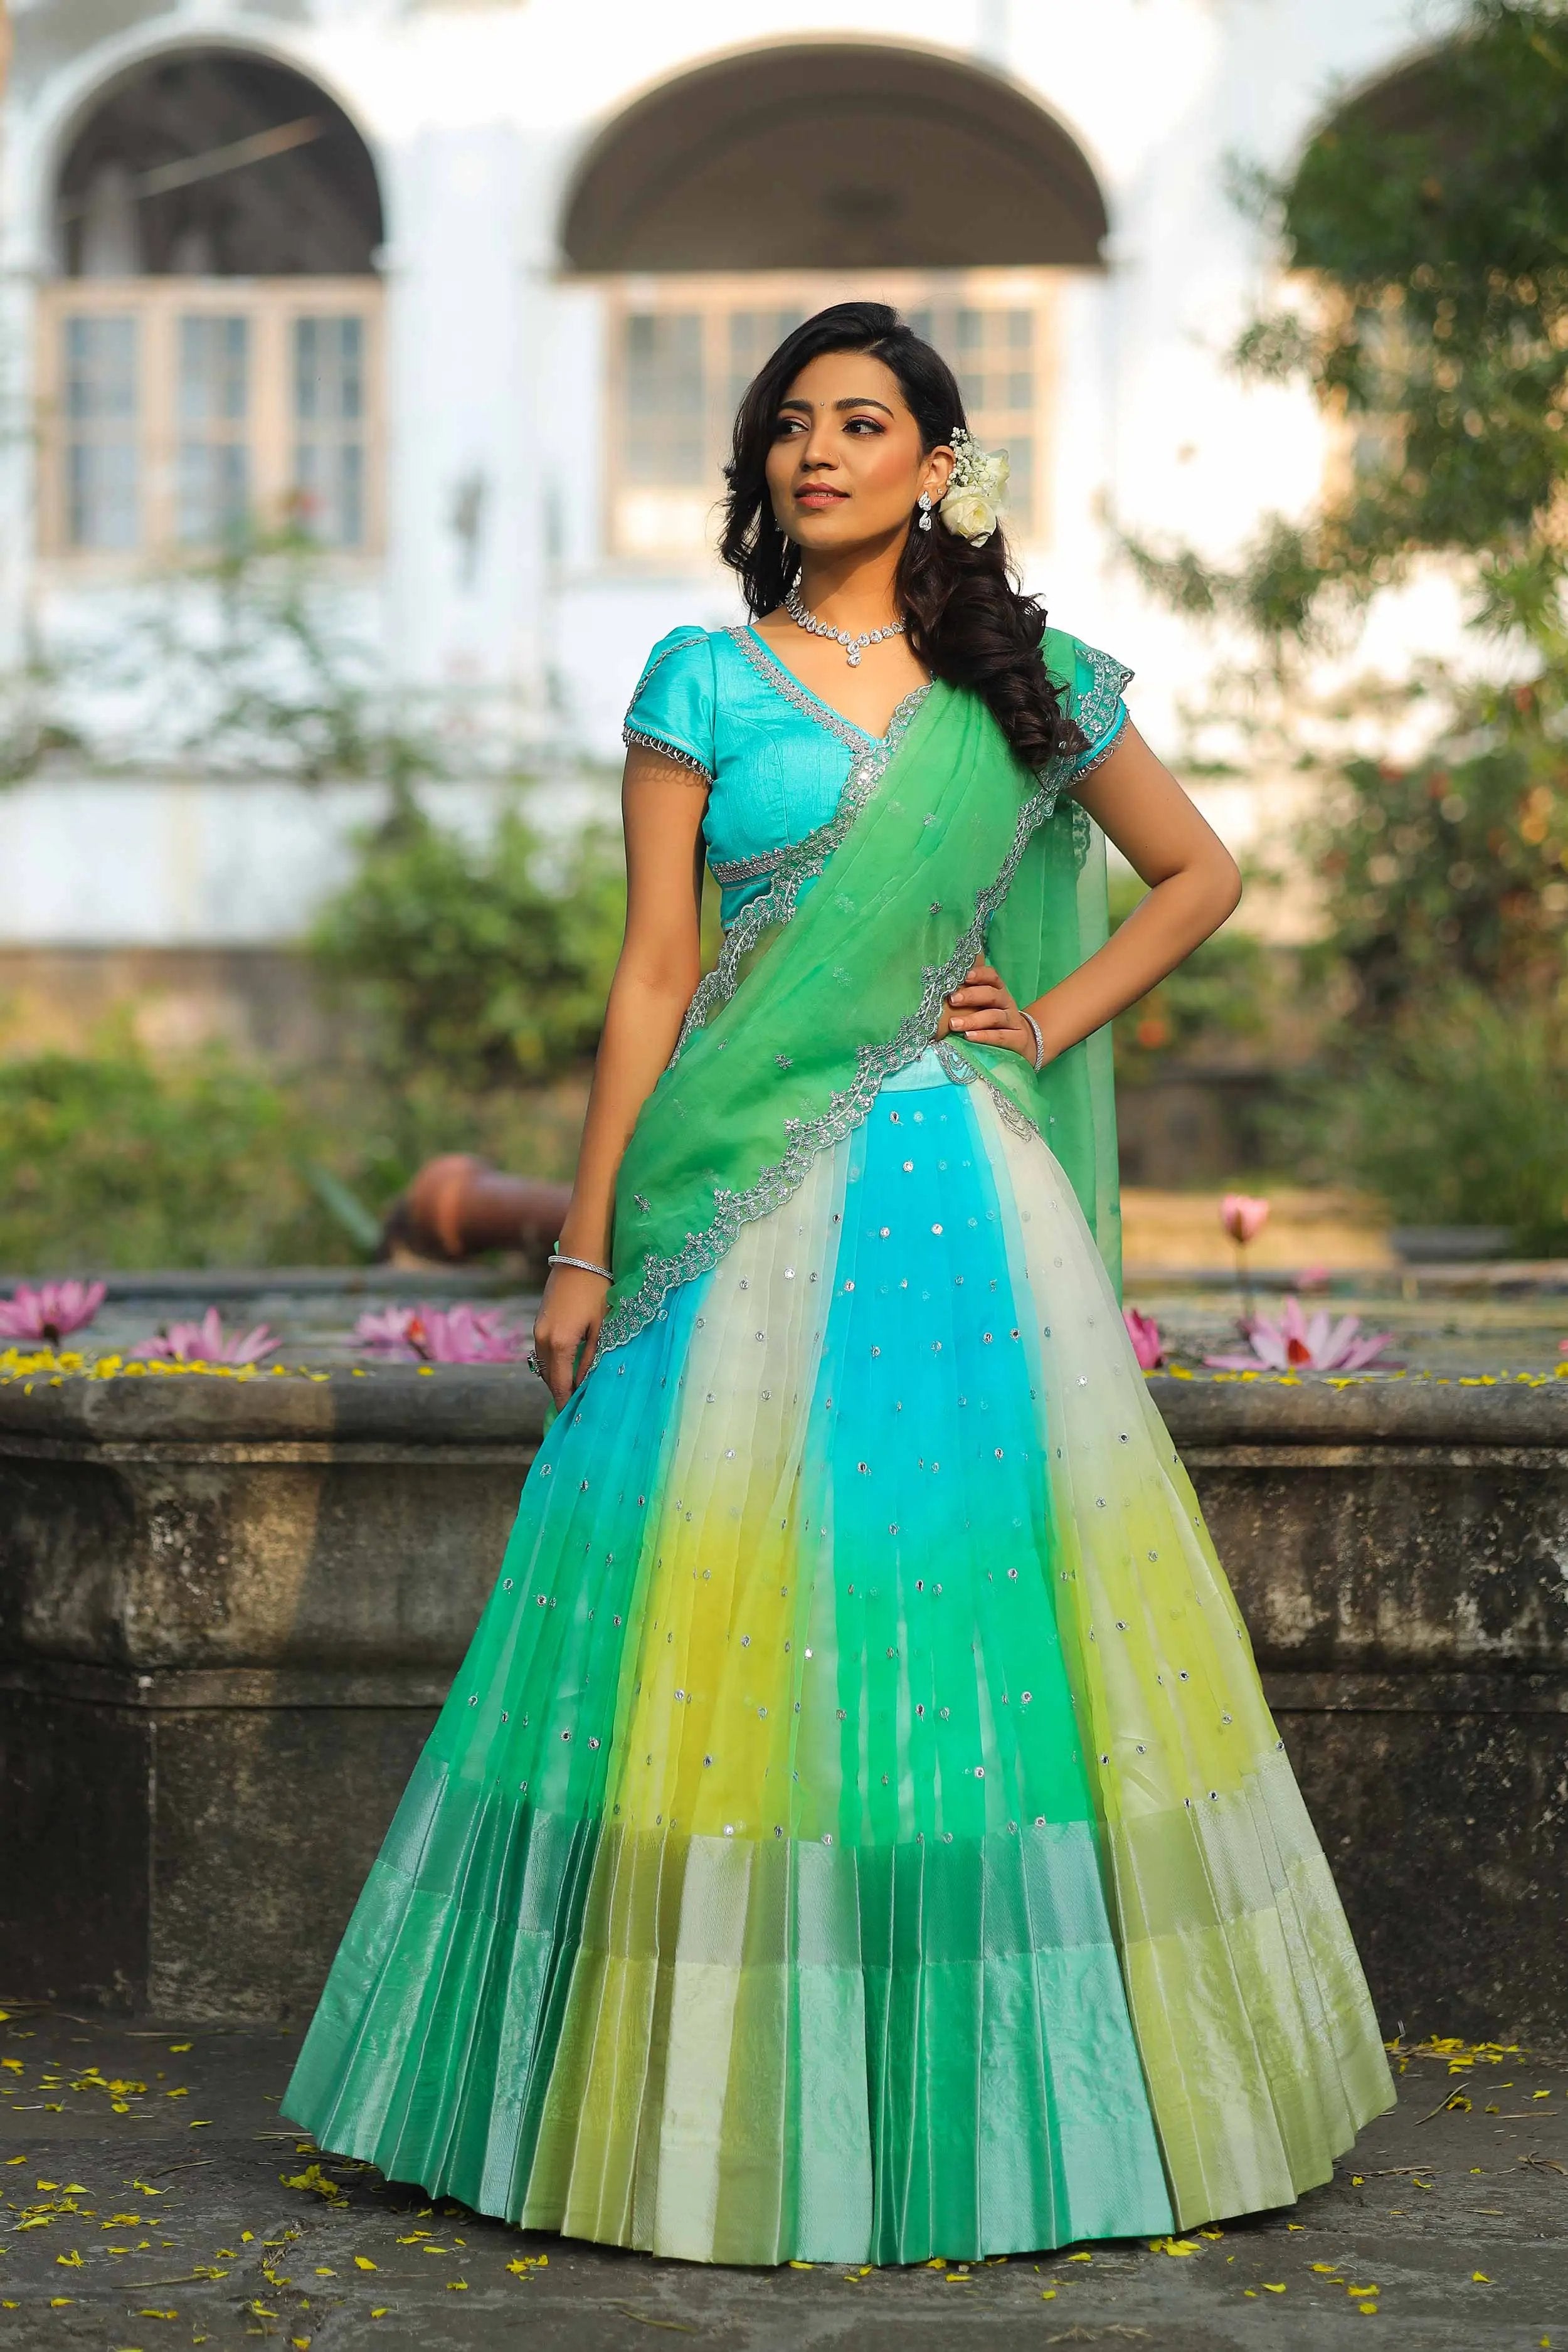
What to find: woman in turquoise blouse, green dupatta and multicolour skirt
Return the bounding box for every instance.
[287,304,1392,2263]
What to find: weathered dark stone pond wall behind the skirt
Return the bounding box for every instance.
[0,1369,1568,2037]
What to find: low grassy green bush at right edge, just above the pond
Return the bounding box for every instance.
[1316,988,1568,1256]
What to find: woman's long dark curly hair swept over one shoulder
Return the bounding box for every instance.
[719,301,1084,769]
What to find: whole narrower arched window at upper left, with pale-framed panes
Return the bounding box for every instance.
[40,50,381,560]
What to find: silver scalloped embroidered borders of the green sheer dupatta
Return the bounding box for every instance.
[597,710,1072,1360]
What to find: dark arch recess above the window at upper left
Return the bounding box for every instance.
[54,43,383,278]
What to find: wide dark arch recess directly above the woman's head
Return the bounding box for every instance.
[562,43,1107,273]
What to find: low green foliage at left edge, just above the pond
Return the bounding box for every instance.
[0,1037,352,1273]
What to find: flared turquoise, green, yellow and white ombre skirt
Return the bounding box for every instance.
[285,1054,1392,2263]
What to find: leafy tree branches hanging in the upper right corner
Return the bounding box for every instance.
[1131,0,1568,659]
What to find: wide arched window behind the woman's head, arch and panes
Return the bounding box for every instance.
[562,43,1107,558]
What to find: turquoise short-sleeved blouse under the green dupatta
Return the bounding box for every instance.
[623,628,1131,929]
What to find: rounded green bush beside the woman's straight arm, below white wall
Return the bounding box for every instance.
[310,795,625,1098]
